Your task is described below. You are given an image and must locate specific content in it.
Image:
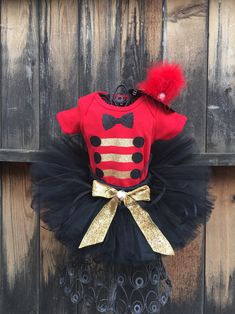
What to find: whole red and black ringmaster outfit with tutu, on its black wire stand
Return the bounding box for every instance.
[32,64,212,313]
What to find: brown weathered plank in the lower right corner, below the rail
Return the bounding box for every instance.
[205,167,235,314]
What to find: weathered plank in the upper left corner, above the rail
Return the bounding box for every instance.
[1,0,39,149]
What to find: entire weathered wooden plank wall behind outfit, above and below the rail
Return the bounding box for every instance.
[0,0,235,314]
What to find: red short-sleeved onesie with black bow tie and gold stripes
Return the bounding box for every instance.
[56,91,187,187]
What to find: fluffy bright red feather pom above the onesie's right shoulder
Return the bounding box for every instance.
[137,61,186,106]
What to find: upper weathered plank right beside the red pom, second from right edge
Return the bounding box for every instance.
[163,0,208,152]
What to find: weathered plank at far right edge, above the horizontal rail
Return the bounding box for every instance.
[207,0,235,153]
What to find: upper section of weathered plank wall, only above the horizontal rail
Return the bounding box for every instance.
[0,0,235,165]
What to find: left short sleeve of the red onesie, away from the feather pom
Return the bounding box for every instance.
[56,101,81,134]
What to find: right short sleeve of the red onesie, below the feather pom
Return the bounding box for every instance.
[153,106,187,140]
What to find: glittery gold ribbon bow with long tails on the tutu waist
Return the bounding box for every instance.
[79,180,174,255]
